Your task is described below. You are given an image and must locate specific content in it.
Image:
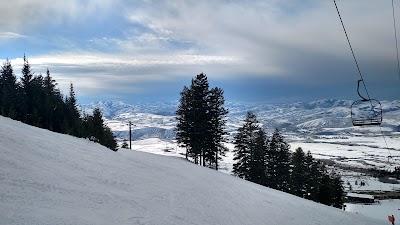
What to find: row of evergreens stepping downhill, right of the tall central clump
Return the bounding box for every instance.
[233,112,344,208]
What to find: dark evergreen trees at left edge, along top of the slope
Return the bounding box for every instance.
[0,56,117,151]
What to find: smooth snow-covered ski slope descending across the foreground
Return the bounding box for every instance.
[0,117,383,225]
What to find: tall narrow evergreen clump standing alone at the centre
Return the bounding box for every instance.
[176,73,228,170]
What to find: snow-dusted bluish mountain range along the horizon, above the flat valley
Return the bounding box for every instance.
[81,99,400,139]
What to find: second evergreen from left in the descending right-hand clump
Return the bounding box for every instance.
[265,129,290,192]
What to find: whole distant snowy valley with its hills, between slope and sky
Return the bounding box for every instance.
[81,99,400,173]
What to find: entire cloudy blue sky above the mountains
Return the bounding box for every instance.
[0,0,400,103]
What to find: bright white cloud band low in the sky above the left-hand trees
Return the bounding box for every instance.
[4,52,240,98]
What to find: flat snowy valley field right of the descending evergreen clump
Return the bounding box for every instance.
[290,134,400,170]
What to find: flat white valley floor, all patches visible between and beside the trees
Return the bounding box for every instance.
[126,136,400,173]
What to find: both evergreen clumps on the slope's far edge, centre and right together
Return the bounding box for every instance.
[175,73,344,208]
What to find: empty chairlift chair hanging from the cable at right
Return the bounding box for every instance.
[350,80,382,126]
